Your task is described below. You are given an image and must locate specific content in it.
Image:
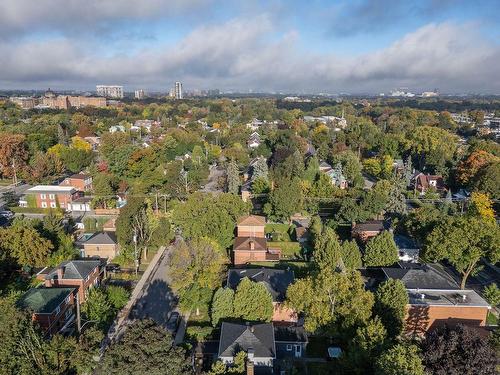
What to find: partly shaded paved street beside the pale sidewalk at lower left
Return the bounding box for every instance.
[131,249,177,326]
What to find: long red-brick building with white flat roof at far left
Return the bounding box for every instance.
[19,185,83,211]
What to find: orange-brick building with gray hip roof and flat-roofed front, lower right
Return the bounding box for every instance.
[382,263,491,335]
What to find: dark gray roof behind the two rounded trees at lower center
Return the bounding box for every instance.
[227,268,295,302]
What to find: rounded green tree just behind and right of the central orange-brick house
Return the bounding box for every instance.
[264,179,303,222]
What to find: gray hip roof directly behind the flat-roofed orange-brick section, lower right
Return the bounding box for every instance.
[382,264,460,290]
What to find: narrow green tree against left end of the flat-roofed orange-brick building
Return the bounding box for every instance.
[374,279,409,337]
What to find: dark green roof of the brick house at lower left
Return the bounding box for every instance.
[18,288,75,314]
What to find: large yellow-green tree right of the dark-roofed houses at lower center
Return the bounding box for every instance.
[286,270,374,333]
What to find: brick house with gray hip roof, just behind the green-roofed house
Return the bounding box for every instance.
[37,259,105,303]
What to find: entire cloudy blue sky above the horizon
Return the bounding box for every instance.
[0,0,500,94]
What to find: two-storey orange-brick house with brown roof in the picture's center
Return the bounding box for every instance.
[233,215,281,265]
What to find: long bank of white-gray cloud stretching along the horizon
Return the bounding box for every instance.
[0,15,500,93]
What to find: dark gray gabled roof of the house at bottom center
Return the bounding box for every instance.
[219,322,276,358]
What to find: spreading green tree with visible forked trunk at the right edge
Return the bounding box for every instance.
[421,217,500,289]
